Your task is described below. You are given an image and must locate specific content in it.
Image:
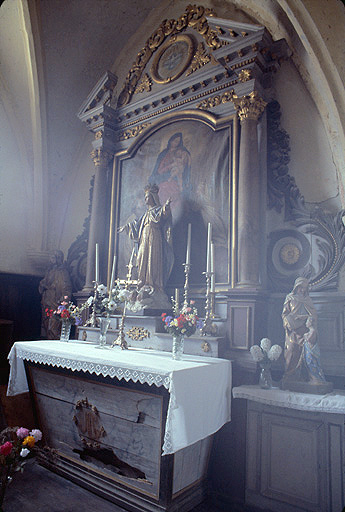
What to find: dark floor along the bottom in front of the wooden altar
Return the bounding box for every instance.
[3,461,228,512]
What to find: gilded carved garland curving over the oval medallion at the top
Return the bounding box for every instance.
[117,5,222,107]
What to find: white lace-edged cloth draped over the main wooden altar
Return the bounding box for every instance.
[7,340,231,455]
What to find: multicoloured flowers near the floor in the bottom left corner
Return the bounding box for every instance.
[0,427,42,510]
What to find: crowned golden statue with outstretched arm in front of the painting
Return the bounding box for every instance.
[118,184,174,309]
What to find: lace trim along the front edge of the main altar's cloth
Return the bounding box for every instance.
[17,348,170,390]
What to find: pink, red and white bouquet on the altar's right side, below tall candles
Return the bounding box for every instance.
[162,299,203,336]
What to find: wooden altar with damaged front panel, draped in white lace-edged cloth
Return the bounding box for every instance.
[8,340,231,512]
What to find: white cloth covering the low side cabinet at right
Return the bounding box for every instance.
[232,385,345,414]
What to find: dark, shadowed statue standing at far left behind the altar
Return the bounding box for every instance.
[38,251,72,340]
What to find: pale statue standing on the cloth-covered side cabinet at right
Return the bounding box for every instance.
[282,277,332,393]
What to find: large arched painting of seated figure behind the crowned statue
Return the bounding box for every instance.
[109,114,234,290]
